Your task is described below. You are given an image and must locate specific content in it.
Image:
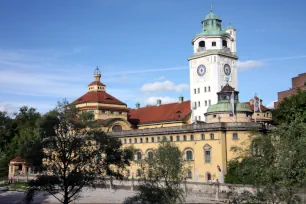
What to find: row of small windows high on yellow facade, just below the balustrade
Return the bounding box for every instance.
[123,133,238,144]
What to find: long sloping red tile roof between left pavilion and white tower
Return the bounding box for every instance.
[128,101,191,125]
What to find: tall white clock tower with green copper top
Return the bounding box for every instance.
[188,8,238,122]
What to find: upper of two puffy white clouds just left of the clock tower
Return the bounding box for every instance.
[140,80,189,92]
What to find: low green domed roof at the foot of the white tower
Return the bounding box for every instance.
[207,102,252,114]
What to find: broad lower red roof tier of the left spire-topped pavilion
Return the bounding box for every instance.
[73,91,126,105]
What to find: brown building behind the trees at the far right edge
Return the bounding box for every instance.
[274,73,306,108]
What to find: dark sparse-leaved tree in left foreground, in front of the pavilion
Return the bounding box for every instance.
[27,100,133,204]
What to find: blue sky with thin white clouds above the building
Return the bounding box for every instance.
[0,0,306,112]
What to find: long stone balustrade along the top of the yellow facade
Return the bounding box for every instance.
[107,123,265,137]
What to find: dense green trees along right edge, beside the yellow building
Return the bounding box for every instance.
[226,91,306,203]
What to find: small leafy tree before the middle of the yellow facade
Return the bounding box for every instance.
[125,141,187,204]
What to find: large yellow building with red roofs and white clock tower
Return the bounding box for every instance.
[73,7,272,183]
